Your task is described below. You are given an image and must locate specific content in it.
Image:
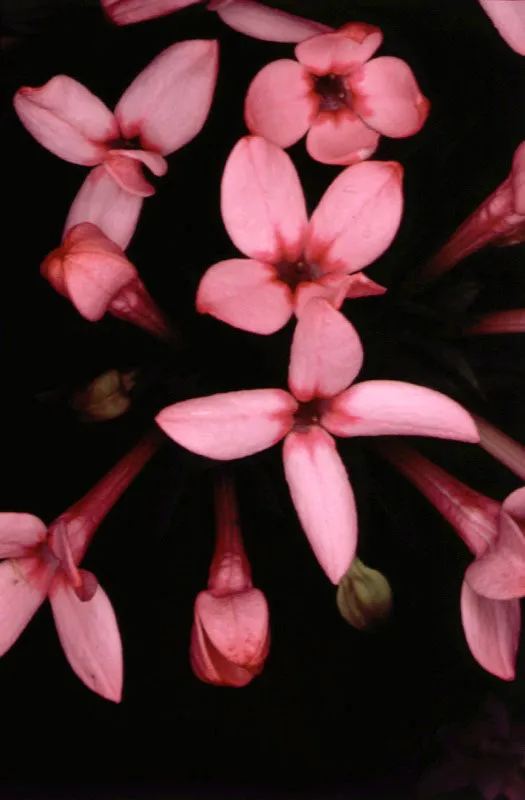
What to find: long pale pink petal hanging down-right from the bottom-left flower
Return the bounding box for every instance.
[49,576,123,703]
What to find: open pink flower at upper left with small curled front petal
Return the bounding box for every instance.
[14,40,218,247]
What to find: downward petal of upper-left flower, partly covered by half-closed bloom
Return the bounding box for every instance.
[63,166,143,250]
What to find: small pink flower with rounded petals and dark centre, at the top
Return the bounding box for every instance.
[244,22,429,164]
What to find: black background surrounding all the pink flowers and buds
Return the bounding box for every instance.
[0,0,525,799]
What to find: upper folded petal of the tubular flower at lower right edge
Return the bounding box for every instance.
[465,512,525,600]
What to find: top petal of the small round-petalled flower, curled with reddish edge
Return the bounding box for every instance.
[295,23,383,75]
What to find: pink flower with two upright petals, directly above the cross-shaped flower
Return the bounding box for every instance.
[196,136,403,334]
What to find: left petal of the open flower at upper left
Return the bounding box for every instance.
[14,75,119,167]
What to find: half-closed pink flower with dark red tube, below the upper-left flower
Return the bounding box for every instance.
[40,222,169,338]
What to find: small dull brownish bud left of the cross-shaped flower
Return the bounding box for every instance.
[72,369,137,422]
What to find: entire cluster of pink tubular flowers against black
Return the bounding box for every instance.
[6,0,525,701]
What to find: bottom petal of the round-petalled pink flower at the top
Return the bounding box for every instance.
[306,109,379,164]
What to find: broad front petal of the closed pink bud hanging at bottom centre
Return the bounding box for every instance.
[195,589,270,671]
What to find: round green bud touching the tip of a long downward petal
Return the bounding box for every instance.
[337,558,392,630]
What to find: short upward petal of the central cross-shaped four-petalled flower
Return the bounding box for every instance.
[288,297,364,403]
